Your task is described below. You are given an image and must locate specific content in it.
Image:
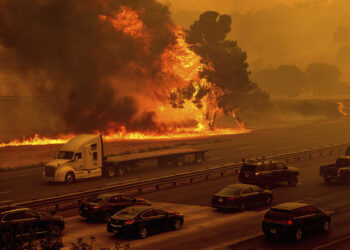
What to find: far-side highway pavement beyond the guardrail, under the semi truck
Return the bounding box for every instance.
[0,117,350,205]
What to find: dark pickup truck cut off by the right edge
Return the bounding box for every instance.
[320,156,350,184]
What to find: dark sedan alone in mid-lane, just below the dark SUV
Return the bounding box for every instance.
[211,184,273,211]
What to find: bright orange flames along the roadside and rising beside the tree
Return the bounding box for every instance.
[0,6,252,147]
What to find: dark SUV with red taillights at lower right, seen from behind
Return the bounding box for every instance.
[262,202,331,240]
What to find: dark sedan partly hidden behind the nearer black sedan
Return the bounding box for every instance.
[79,194,151,222]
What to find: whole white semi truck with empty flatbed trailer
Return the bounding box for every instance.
[42,134,207,184]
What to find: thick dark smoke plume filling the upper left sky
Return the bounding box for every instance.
[0,0,174,137]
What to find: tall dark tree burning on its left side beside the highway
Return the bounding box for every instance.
[170,11,269,129]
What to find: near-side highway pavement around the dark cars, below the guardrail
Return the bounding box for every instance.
[56,156,350,249]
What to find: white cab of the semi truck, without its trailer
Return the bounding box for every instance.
[43,134,103,184]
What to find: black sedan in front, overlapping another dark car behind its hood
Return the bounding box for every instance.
[107,206,184,238]
